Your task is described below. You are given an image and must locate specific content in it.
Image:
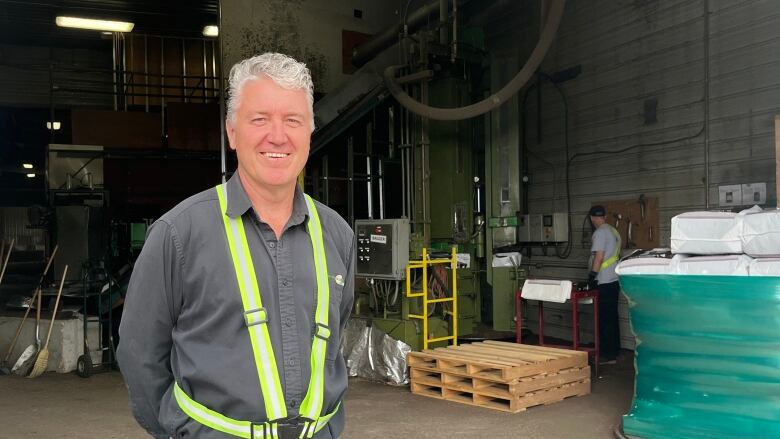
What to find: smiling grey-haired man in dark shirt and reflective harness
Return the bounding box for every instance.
[117,53,354,439]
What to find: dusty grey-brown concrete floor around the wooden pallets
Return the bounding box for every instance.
[0,352,634,439]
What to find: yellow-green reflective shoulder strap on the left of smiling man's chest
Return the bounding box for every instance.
[217,185,287,420]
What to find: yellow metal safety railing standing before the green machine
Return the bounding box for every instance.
[406,247,458,349]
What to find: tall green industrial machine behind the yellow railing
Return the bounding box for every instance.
[306,11,544,350]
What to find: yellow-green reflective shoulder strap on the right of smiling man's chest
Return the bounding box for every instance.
[300,195,330,430]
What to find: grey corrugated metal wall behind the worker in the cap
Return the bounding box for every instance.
[524,0,780,348]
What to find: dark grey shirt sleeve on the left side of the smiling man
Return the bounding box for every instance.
[117,221,183,438]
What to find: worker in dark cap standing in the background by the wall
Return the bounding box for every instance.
[588,206,621,364]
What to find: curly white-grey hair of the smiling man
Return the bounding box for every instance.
[225,52,314,131]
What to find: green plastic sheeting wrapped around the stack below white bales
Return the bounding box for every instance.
[620,275,780,439]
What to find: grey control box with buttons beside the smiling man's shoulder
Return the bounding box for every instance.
[355,218,409,280]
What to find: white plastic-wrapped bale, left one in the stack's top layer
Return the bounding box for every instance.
[671,212,742,255]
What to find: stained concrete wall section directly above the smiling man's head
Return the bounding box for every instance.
[220,0,400,92]
